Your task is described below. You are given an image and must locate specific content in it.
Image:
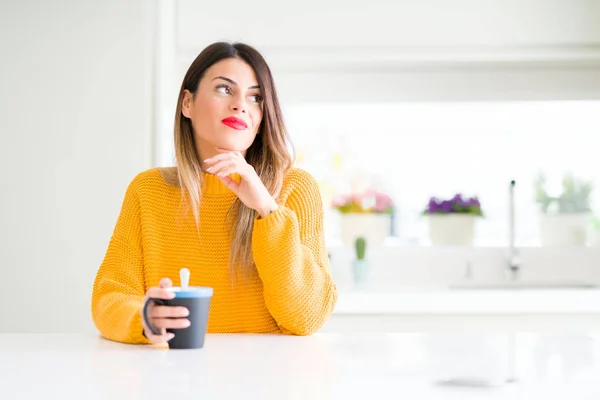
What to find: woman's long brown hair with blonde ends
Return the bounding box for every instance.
[175,42,293,281]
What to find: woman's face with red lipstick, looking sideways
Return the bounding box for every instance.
[181,58,263,160]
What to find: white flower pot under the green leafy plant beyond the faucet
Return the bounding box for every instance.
[540,213,590,246]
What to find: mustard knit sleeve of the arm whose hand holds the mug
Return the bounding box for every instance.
[92,181,149,343]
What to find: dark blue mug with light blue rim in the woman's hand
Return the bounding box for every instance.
[143,286,213,349]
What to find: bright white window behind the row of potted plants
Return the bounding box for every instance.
[284,101,600,246]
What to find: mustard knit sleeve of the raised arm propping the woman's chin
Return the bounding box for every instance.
[252,172,337,335]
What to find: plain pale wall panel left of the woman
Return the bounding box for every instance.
[0,0,152,332]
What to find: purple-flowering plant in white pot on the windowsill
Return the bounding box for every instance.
[422,193,483,246]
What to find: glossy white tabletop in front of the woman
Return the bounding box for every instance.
[0,333,600,400]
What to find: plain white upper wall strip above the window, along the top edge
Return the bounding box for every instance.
[177,0,600,50]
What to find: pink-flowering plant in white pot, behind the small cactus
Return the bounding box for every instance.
[333,190,394,246]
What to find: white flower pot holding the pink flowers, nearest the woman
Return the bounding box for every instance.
[340,213,391,245]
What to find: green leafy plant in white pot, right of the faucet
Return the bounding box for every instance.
[534,172,592,246]
